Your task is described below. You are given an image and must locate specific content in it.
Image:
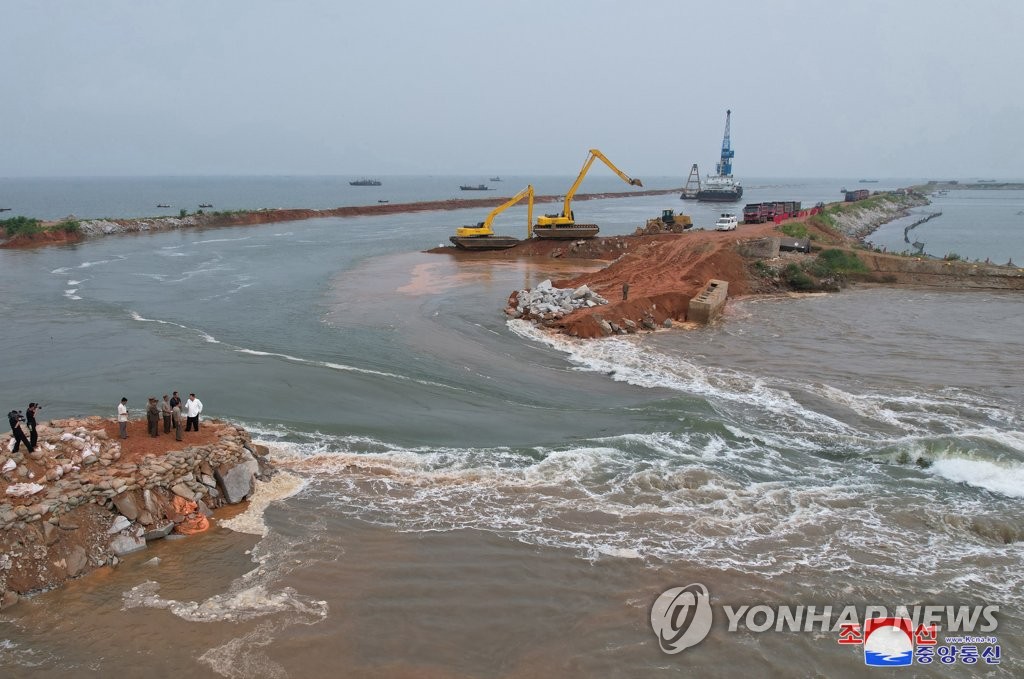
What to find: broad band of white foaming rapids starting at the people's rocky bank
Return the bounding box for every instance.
[239,425,1020,610]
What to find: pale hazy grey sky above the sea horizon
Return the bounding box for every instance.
[0,0,1024,178]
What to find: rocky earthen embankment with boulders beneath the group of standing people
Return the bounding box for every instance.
[0,417,273,609]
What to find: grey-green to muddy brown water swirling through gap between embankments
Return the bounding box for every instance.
[0,178,1024,677]
